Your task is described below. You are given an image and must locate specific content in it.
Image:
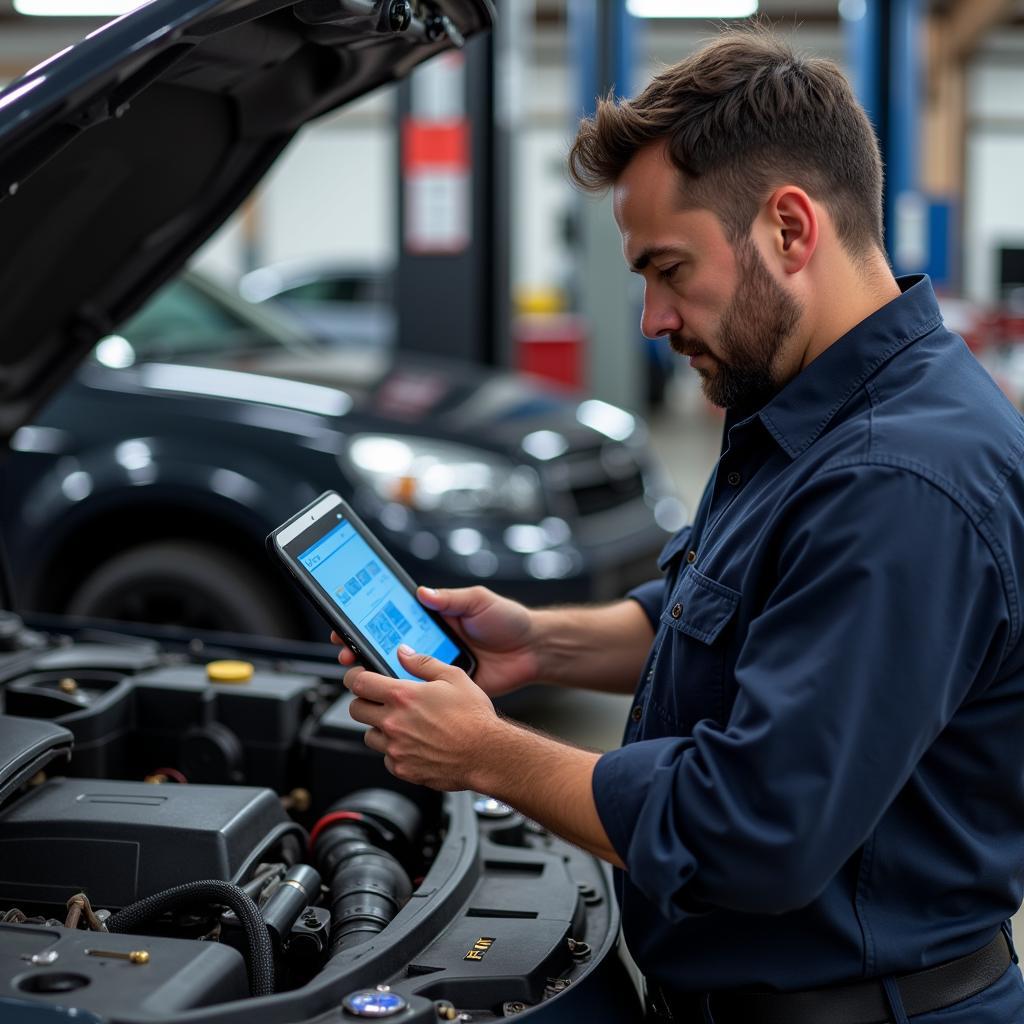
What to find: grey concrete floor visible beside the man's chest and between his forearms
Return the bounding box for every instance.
[507,369,1024,970]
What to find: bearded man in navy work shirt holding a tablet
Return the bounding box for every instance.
[340,29,1024,1024]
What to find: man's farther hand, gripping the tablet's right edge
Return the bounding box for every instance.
[331,587,540,697]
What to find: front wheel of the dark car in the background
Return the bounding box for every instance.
[67,541,293,636]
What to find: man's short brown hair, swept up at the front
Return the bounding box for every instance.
[569,26,883,257]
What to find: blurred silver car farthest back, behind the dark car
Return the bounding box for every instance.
[239,261,398,348]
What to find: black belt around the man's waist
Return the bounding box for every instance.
[655,929,1012,1024]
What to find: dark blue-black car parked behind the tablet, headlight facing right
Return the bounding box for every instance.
[0,273,680,637]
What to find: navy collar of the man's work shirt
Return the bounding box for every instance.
[757,274,942,459]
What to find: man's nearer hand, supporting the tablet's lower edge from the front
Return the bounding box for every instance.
[345,644,502,790]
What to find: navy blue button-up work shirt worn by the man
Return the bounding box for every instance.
[593,278,1024,991]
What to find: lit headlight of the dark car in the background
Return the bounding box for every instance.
[346,434,542,518]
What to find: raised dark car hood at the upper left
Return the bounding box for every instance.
[0,0,494,442]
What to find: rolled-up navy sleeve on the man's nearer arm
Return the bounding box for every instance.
[593,465,1012,920]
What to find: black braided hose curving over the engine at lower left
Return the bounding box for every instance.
[106,880,273,995]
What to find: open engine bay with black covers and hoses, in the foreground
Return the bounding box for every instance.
[0,613,638,1024]
